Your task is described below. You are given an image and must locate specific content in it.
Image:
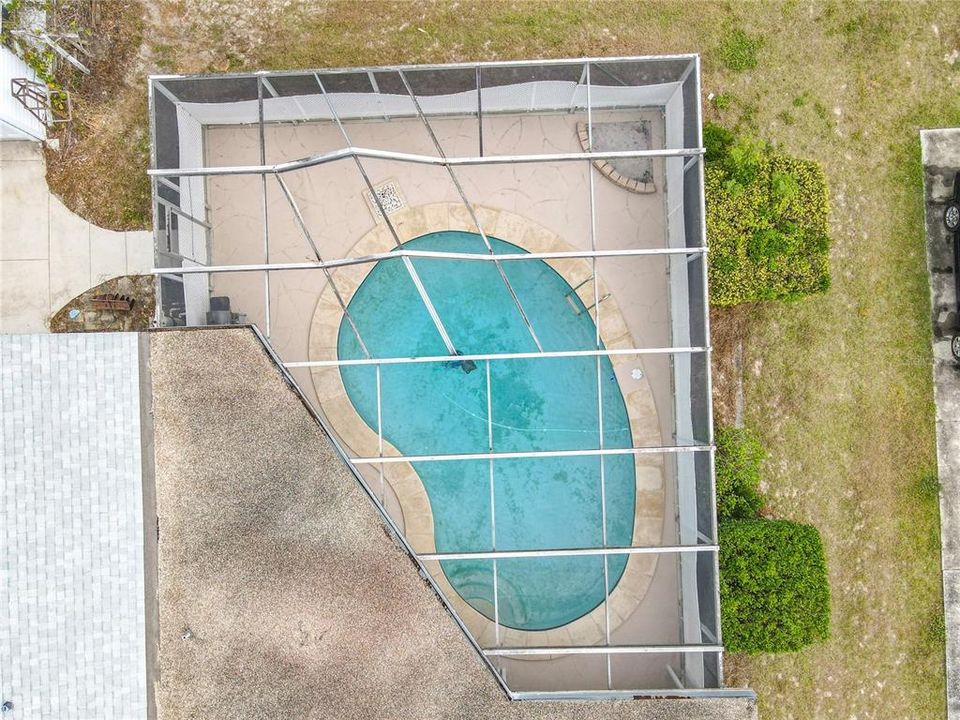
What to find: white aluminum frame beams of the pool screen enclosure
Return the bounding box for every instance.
[149,55,749,700]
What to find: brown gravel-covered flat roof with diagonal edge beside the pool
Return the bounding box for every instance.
[150,329,756,720]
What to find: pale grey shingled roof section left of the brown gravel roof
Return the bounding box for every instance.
[0,334,147,720]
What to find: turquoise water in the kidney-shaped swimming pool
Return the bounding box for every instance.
[338,231,635,630]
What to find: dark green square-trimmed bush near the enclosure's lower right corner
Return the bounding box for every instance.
[720,520,830,653]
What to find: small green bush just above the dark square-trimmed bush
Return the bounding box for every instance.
[714,426,766,521]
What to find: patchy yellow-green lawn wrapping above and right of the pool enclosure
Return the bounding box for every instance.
[52,0,960,720]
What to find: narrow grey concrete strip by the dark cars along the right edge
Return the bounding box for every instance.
[920,129,960,720]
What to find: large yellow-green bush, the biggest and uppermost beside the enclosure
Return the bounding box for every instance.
[704,125,830,306]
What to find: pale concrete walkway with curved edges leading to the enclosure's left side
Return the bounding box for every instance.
[0,141,153,333]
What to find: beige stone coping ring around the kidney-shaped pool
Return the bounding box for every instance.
[309,203,665,648]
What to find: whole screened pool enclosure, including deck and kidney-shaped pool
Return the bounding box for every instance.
[149,55,744,699]
